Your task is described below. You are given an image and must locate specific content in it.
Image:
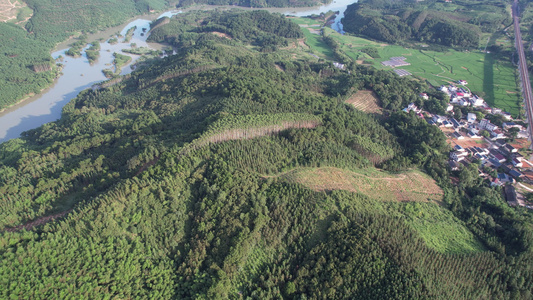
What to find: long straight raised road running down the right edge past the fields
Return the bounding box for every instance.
[513,0,533,149]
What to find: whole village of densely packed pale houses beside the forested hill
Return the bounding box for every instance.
[403,80,533,209]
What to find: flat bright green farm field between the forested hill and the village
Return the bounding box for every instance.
[315,28,521,116]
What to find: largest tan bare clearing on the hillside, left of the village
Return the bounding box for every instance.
[279,167,443,202]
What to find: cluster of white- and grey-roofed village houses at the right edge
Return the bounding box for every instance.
[404,80,533,209]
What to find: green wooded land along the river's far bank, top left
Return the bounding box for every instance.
[0,0,330,110]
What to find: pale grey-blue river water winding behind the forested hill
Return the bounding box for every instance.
[0,0,357,143]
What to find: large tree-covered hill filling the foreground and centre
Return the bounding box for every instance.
[0,11,533,299]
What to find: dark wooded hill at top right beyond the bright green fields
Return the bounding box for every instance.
[342,0,511,48]
